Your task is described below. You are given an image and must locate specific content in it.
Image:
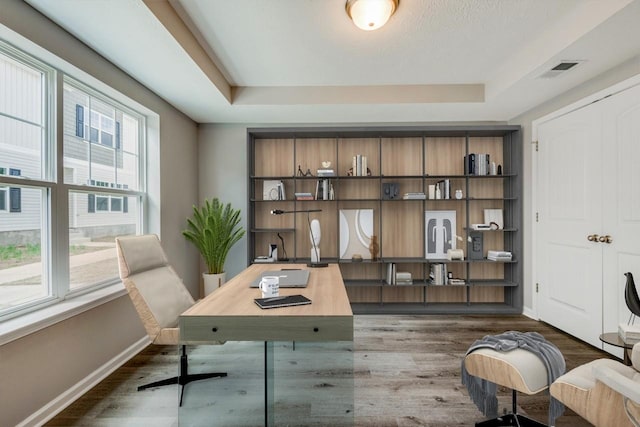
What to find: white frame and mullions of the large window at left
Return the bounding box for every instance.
[0,40,149,324]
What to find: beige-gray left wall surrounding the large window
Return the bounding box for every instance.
[0,0,200,426]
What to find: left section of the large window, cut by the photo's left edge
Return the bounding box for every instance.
[0,42,48,316]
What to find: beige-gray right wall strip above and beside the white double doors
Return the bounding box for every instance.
[509,53,640,319]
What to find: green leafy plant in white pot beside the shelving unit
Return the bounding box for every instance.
[182,198,245,295]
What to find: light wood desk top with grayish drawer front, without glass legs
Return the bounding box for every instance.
[180,264,353,342]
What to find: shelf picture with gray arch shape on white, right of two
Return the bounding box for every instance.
[424,211,457,259]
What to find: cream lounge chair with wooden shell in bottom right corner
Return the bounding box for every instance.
[550,343,640,427]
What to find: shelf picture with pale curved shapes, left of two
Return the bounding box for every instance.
[340,209,373,259]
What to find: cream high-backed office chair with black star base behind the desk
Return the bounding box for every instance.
[116,234,227,405]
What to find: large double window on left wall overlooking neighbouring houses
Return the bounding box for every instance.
[0,42,146,319]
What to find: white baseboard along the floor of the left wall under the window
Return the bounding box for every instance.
[17,336,149,427]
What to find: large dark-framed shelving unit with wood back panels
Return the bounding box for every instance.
[247,126,522,313]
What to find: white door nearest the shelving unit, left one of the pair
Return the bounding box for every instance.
[536,103,613,347]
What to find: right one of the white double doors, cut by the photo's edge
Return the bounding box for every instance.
[601,86,640,342]
